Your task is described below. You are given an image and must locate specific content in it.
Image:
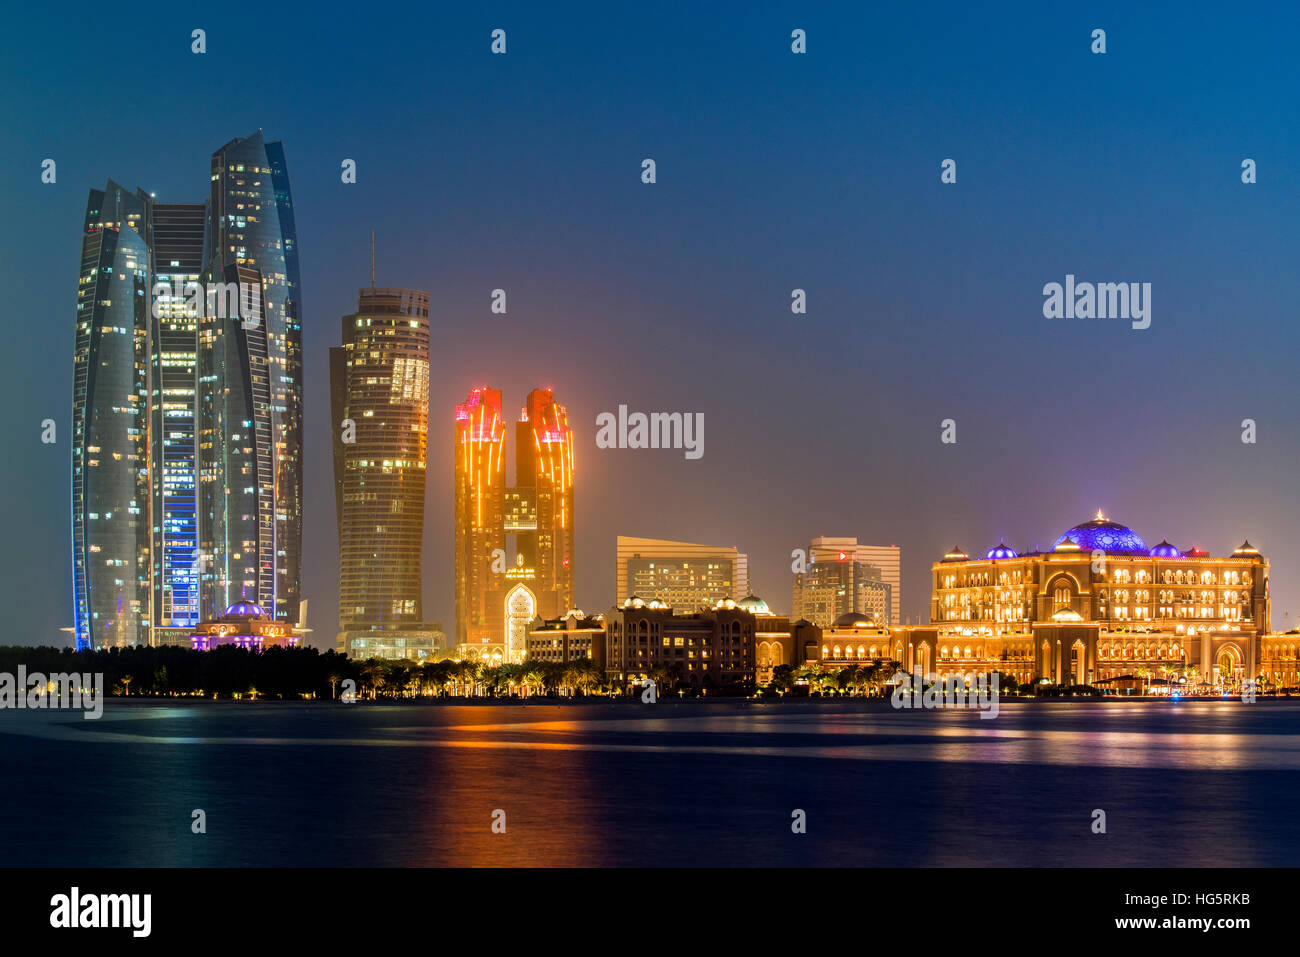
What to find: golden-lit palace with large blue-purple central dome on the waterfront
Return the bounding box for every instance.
[920,512,1274,689]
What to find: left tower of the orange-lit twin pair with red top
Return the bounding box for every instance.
[455,386,506,648]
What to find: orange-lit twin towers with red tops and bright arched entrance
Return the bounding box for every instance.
[455,386,573,661]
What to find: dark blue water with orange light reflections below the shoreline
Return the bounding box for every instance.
[0,700,1300,867]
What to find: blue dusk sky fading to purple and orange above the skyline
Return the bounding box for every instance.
[0,3,1300,648]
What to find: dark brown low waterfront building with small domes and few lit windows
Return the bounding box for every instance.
[605,596,757,692]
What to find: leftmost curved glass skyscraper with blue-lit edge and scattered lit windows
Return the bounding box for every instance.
[72,179,150,649]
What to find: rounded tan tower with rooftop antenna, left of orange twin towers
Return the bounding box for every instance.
[330,286,442,659]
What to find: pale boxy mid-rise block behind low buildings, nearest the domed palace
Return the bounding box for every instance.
[790,537,898,628]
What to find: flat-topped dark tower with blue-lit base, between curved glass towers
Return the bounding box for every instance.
[150,202,207,644]
